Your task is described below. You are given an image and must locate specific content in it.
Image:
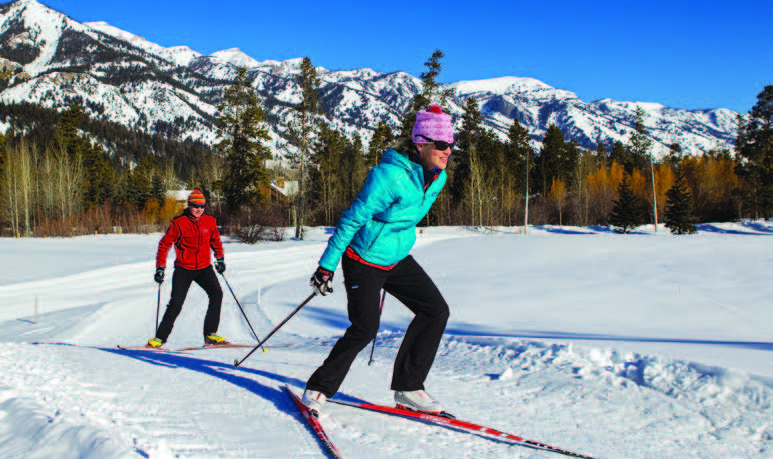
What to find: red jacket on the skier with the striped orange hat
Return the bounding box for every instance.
[156,209,223,270]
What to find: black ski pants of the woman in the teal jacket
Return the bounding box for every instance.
[306,255,449,397]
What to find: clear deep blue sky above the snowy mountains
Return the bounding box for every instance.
[37,0,773,113]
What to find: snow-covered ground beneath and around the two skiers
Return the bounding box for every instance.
[0,222,773,458]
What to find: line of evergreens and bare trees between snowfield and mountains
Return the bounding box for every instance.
[0,51,773,239]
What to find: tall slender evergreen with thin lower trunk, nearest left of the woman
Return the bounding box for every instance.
[288,57,321,240]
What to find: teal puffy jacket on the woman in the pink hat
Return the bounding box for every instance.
[319,150,446,271]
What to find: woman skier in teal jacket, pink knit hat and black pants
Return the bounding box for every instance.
[303,105,454,414]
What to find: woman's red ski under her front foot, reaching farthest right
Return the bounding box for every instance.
[328,399,593,459]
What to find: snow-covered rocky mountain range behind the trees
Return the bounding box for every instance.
[0,0,737,158]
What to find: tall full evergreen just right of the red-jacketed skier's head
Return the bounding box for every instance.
[216,67,271,213]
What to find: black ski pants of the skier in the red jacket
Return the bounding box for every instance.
[156,266,223,342]
